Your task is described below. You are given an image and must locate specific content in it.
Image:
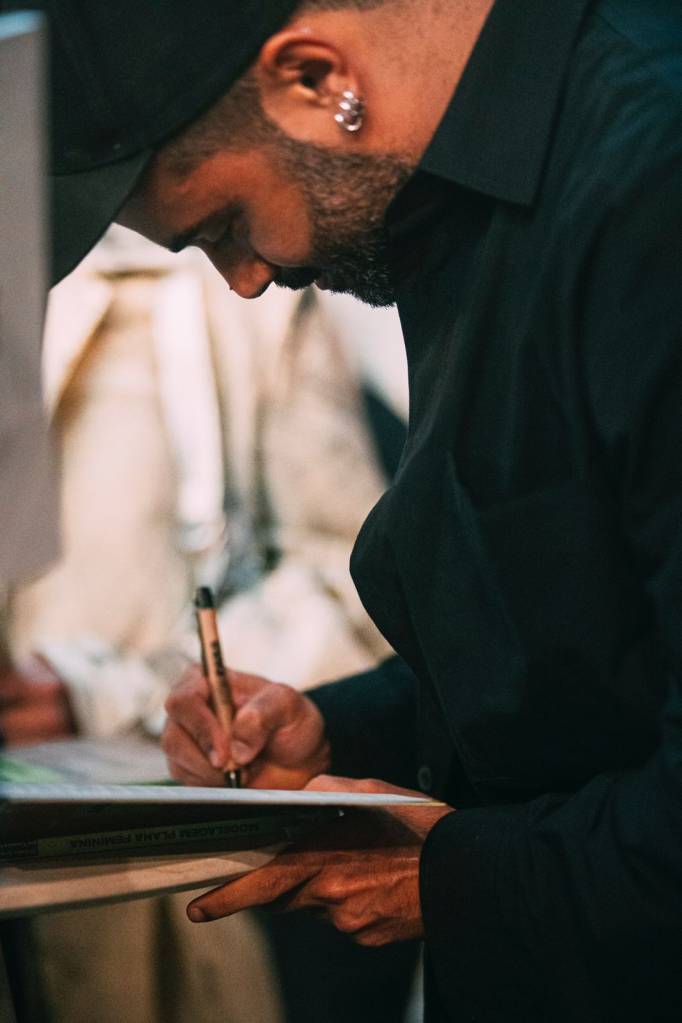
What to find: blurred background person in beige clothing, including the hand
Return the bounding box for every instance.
[0,228,416,1023]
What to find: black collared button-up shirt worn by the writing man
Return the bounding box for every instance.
[316,0,682,1023]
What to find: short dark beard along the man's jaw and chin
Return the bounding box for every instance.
[271,130,414,306]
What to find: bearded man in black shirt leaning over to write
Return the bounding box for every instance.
[33,0,682,1023]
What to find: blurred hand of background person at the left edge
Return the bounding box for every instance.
[0,655,76,746]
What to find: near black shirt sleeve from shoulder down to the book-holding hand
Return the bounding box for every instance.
[421,148,682,1023]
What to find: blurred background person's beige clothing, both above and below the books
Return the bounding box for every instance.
[2,230,402,1023]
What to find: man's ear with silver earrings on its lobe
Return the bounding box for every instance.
[255,29,360,144]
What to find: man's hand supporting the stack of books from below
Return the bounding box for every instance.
[187,776,452,945]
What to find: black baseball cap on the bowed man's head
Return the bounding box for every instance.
[6,0,300,283]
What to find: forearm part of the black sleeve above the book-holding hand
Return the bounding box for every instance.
[421,686,682,1023]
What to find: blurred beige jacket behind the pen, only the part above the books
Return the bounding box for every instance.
[12,232,389,735]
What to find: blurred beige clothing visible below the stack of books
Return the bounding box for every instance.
[33,894,283,1023]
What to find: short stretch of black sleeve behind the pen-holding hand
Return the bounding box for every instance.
[308,657,417,789]
